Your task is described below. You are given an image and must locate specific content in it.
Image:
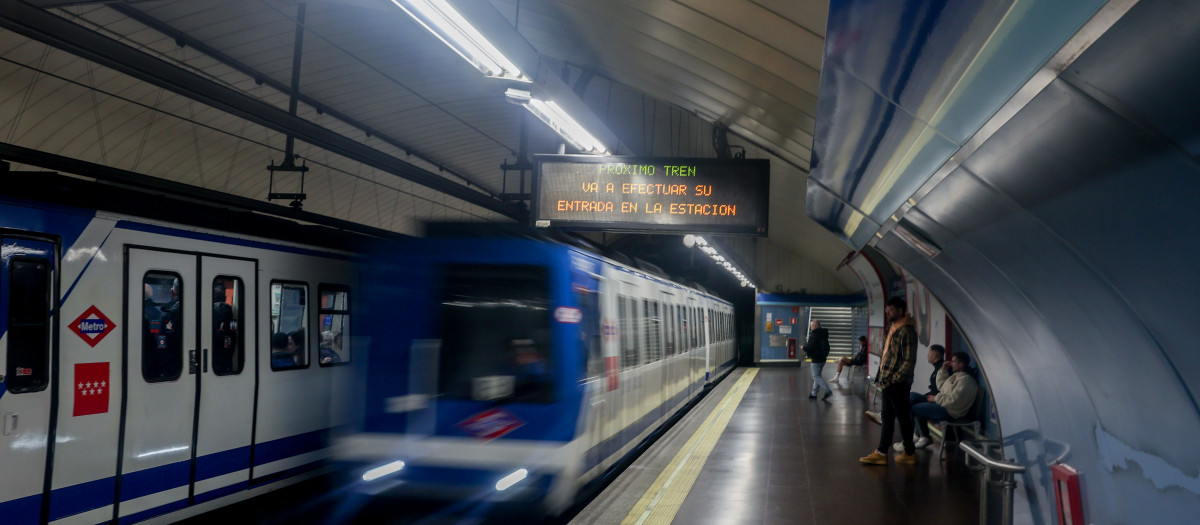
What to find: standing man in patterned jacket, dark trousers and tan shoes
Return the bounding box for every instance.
[858,297,917,465]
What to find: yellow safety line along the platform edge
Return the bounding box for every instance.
[620,368,758,525]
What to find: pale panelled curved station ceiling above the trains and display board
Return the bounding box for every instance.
[0,0,860,292]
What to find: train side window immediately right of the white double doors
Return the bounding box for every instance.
[271,282,308,370]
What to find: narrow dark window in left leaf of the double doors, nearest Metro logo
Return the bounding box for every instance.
[142,272,186,382]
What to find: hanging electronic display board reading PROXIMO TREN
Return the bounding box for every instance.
[532,155,770,235]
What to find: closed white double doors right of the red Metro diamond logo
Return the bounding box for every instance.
[118,247,254,520]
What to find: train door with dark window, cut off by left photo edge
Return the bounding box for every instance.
[0,236,58,523]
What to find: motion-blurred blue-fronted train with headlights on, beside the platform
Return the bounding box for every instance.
[335,237,734,515]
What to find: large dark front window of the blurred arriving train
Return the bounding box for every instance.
[438,265,553,403]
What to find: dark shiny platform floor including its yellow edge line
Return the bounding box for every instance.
[570,364,979,525]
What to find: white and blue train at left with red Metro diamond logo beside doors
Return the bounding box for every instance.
[0,174,362,525]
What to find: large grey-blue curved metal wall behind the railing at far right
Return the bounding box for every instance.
[876,1,1200,524]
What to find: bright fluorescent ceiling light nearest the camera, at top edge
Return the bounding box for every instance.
[391,0,529,82]
